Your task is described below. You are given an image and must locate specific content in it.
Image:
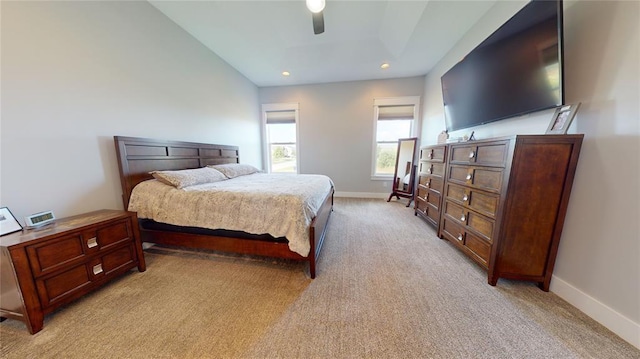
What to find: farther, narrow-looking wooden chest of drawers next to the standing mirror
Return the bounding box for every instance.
[414,144,447,233]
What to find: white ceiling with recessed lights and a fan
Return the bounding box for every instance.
[149,0,497,87]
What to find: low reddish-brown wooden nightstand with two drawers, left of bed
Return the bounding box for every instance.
[0,210,146,334]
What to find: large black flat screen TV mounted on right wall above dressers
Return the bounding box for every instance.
[441,0,564,131]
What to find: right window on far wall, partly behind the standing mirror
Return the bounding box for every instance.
[371,96,420,180]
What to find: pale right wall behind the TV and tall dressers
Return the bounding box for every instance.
[422,1,640,347]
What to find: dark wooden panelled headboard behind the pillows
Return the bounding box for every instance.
[113,136,240,209]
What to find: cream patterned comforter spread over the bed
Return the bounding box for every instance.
[129,173,333,257]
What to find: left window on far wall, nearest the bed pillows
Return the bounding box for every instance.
[262,104,298,173]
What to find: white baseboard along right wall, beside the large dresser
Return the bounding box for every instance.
[549,275,640,349]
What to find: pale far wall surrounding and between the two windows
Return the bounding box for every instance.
[259,76,424,197]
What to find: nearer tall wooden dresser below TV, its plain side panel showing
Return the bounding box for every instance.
[439,135,583,291]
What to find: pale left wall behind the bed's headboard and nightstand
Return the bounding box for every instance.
[0,1,262,222]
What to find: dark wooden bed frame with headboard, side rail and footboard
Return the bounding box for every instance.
[114,136,334,279]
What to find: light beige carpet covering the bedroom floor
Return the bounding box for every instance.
[0,198,640,358]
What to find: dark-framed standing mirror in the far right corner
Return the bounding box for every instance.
[387,137,418,207]
